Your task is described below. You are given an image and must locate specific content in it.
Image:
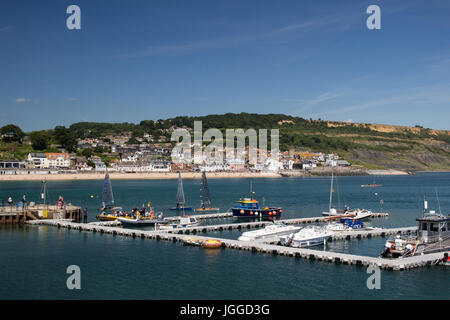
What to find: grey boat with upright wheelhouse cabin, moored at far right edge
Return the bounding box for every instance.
[381,199,450,258]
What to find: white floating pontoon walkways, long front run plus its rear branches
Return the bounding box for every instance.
[23,216,432,271]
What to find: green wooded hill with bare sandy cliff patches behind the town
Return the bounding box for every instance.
[0,113,450,170]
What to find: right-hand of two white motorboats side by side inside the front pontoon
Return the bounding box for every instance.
[280,226,333,248]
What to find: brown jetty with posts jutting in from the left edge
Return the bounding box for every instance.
[0,202,82,224]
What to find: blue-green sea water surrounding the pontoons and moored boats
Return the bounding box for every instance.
[0,173,450,299]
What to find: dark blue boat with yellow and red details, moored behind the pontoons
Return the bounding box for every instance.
[231,182,283,218]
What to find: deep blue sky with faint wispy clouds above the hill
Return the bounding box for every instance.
[0,0,450,131]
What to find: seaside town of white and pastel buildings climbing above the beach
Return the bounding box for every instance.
[0,126,351,175]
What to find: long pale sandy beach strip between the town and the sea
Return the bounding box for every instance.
[0,170,438,181]
